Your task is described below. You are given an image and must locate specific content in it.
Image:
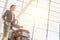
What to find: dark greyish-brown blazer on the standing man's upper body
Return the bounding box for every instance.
[2,10,15,23]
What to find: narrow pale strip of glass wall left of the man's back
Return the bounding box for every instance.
[0,0,6,40]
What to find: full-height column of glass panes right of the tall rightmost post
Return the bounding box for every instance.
[48,0,60,40]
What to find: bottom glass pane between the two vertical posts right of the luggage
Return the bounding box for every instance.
[33,27,46,40]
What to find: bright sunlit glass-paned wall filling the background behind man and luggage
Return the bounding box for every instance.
[0,0,60,40]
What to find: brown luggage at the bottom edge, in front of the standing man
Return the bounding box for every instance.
[12,29,30,40]
